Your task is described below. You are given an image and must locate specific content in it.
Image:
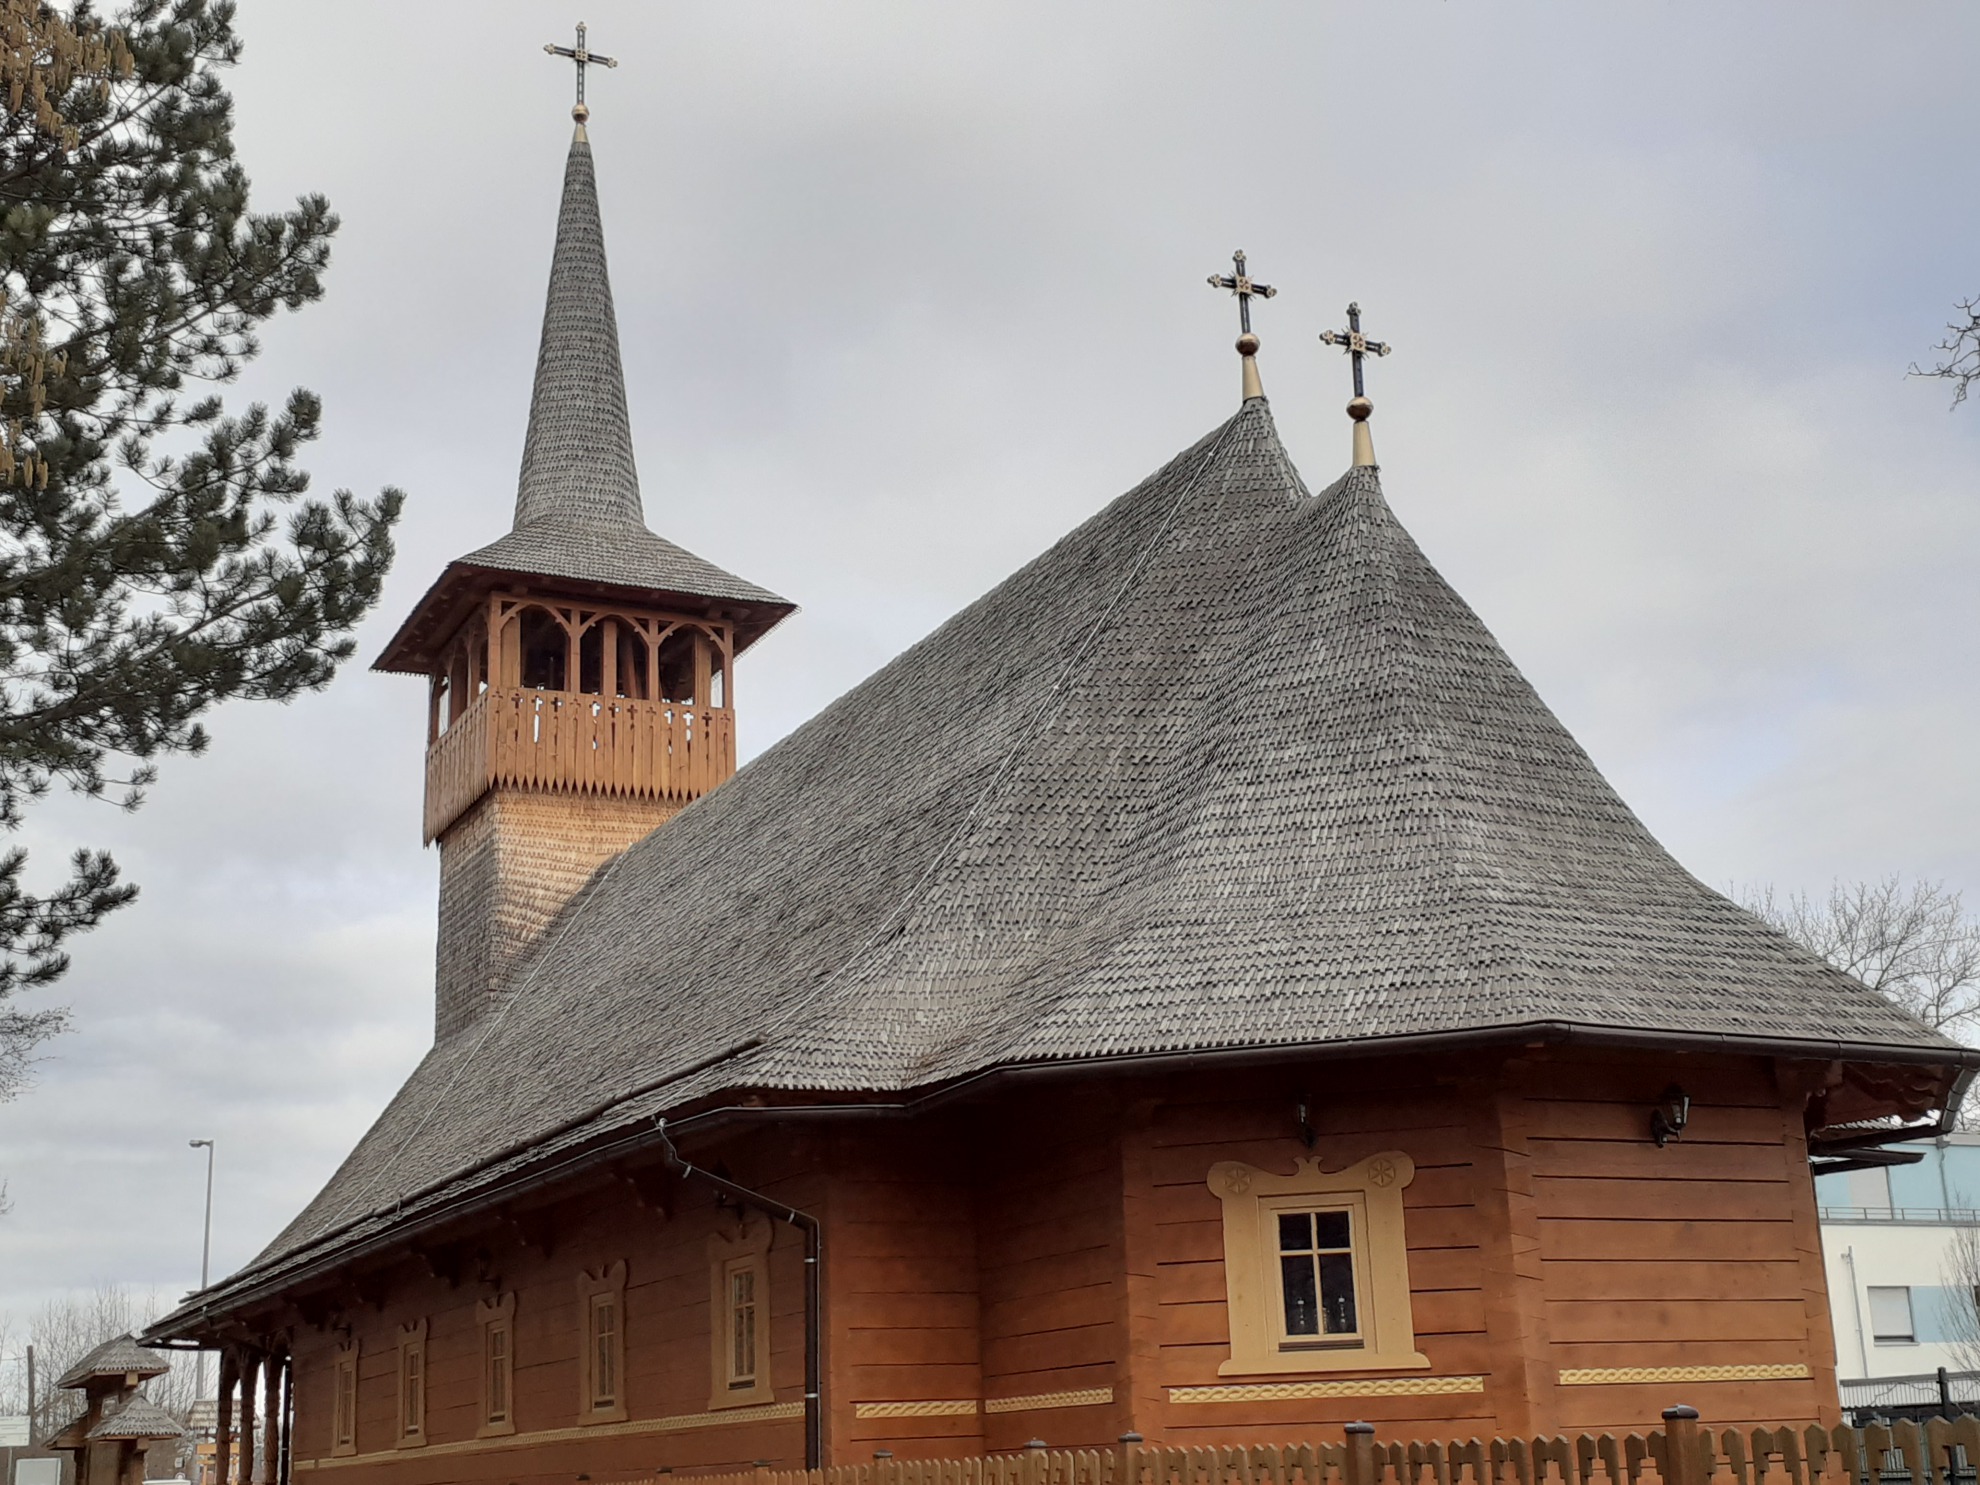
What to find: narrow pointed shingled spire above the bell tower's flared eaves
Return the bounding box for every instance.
[515,119,644,529]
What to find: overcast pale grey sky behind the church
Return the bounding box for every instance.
[0,0,1980,1315]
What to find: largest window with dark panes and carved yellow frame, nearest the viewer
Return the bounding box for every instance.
[1210,1150,1430,1376]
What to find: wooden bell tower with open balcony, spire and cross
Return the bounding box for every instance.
[372,90,792,1041]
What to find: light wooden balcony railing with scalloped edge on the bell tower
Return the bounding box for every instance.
[426,687,737,840]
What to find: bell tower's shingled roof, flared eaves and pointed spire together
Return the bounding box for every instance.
[374,125,792,673]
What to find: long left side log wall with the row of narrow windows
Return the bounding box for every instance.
[293,1137,826,1485]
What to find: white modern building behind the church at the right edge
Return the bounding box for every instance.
[1816,1135,1980,1384]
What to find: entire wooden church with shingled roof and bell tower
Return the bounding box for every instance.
[150,69,1974,1485]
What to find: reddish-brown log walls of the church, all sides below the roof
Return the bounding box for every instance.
[267,1051,1853,1485]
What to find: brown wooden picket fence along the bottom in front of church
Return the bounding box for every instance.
[651,1408,1980,1485]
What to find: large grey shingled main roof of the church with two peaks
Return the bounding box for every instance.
[166,398,1966,1303]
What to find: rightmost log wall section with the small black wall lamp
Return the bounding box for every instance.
[1527,1059,1841,1430]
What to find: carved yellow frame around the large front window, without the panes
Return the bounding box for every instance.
[1208,1150,1430,1376]
